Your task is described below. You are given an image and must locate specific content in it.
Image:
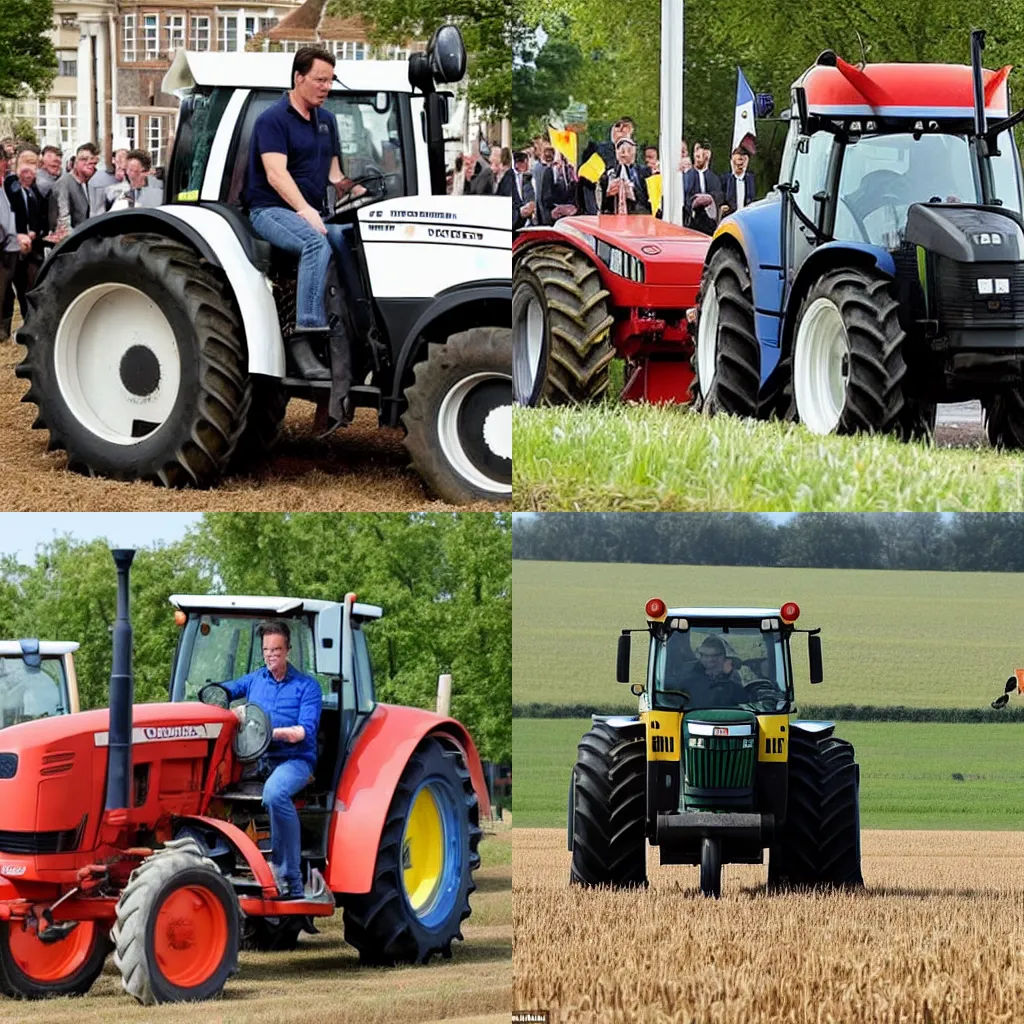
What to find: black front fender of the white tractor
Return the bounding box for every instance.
[378,280,512,401]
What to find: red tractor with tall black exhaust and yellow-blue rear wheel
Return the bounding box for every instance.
[0,551,489,1005]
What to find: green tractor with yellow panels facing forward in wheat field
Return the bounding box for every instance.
[568,598,863,897]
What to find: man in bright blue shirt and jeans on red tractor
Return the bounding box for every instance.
[221,623,324,900]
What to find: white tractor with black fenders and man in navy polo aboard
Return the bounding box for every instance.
[16,27,512,504]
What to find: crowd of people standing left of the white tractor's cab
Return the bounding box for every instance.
[0,139,164,342]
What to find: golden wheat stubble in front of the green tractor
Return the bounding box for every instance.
[512,829,1024,1024]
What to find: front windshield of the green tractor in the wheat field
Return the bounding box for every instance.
[648,624,791,714]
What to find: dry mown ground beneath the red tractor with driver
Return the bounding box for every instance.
[0,829,512,1024]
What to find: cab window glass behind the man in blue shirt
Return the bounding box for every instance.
[171,614,333,700]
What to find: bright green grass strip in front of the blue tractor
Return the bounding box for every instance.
[512,404,1024,512]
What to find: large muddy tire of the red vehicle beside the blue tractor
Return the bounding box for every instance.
[512,245,615,406]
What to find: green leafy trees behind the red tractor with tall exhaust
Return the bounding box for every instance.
[0,512,512,763]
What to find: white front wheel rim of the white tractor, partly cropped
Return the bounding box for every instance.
[437,373,512,496]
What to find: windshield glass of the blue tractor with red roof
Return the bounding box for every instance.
[833,133,1021,250]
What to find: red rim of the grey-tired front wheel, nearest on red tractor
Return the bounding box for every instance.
[153,886,227,988]
